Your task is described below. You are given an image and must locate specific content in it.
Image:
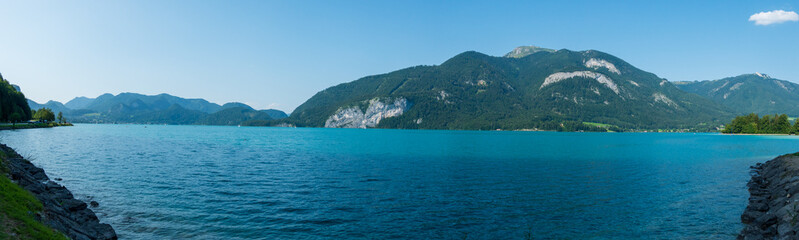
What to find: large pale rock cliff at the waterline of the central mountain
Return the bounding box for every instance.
[325,98,409,128]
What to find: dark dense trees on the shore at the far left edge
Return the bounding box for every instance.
[0,72,32,122]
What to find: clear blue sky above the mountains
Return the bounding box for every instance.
[0,0,799,112]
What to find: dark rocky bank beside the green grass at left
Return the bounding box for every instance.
[0,144,117,240]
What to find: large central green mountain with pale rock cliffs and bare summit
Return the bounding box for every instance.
[285,47,732,130]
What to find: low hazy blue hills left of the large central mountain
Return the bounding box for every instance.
[28,93,286,125]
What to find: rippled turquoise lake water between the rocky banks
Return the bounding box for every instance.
[0,125,799,239]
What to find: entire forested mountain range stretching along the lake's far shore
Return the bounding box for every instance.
[18,46,799,131]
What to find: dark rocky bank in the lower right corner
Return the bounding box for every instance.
[738,153,799,240]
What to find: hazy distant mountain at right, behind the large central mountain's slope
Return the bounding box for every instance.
[675,73,799,116]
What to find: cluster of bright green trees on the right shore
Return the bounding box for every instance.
[721,113,799,134]
